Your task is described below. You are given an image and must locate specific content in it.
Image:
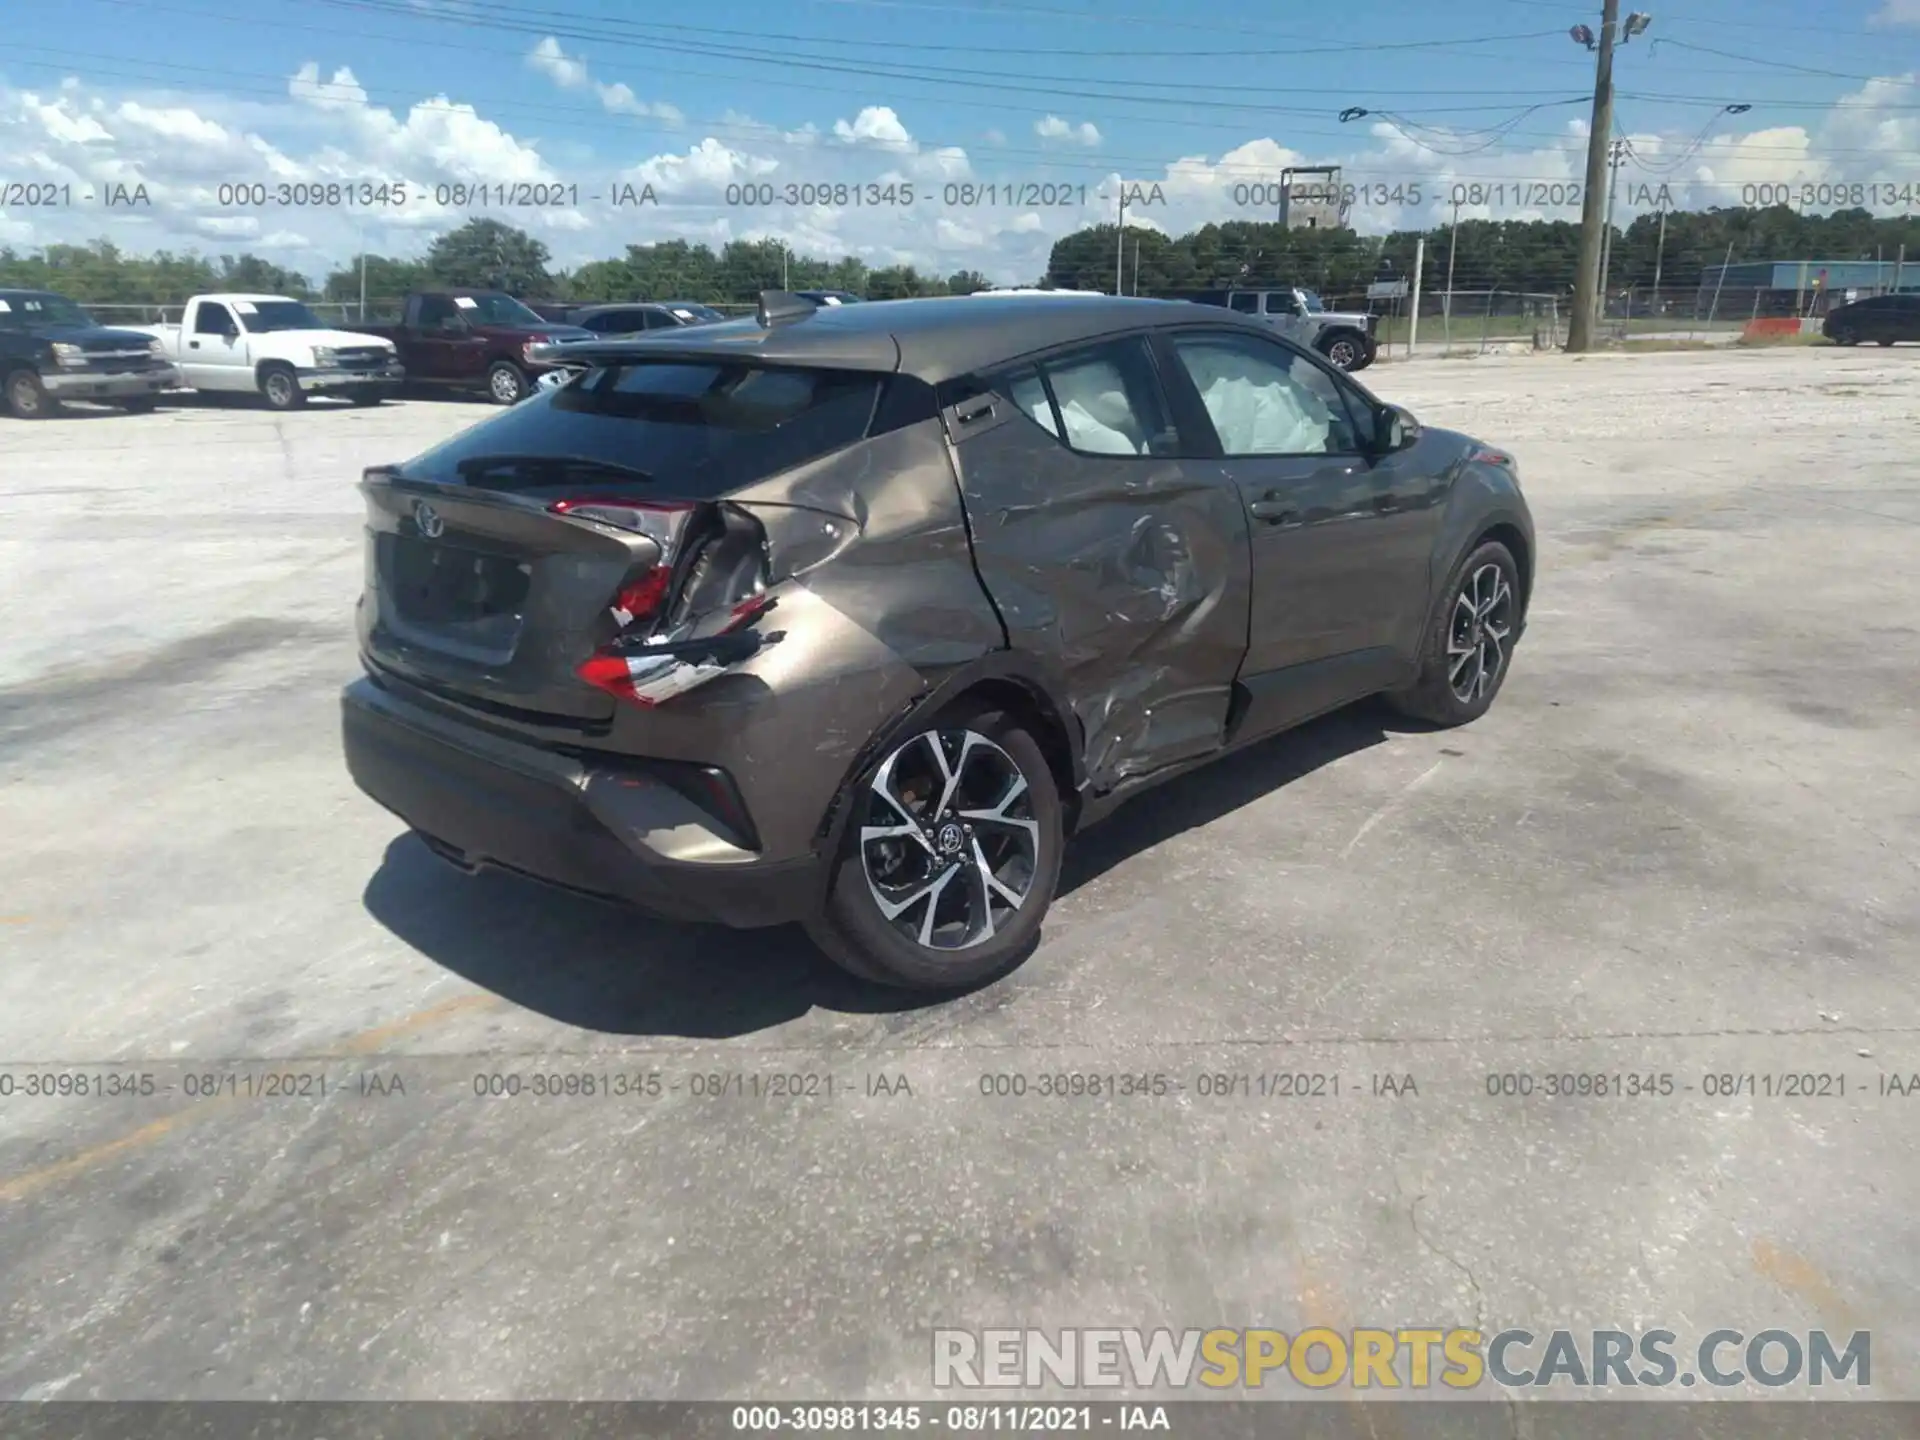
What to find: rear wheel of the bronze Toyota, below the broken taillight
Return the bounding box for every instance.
[806,708,1064,991]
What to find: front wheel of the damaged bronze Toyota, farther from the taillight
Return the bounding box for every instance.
[1386,540,1521,728]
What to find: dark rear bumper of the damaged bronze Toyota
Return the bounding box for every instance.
[340,680,824,929]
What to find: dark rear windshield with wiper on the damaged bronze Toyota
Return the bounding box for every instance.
[401,363,883,499]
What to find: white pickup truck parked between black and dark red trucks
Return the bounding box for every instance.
[132,296,407,411]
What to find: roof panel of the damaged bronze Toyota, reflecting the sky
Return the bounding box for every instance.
[541,294,1269,384]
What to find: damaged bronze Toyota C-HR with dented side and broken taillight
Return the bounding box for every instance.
[344,292,1534,989]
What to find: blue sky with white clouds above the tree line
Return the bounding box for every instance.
[0,0,1920,284]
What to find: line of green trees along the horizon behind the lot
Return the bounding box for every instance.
[0,205,1920,305]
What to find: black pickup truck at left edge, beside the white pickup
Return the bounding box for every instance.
[0,290,180,420]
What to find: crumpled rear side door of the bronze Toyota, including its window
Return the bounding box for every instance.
[943,336,1250,791]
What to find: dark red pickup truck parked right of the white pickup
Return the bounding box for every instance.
[353,290,595,405]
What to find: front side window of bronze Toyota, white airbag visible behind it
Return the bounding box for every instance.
[1173,334,1361,455]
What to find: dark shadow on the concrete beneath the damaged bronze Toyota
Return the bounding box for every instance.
[363,703,1419,1039]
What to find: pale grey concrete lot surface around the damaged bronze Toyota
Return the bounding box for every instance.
[0,349,1920,1400]
